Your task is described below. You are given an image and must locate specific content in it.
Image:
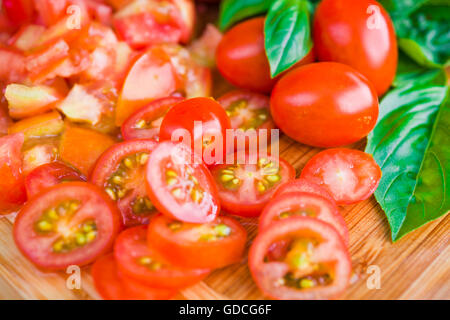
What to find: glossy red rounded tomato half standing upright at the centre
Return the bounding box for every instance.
[159,98,231,165]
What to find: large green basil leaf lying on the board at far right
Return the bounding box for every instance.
[366,84,450,241]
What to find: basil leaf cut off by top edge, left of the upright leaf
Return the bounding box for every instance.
[219,0,272,31]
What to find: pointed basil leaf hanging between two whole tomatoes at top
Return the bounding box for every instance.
[264,0,312,78]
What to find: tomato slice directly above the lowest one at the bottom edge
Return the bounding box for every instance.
[114,226,210,289]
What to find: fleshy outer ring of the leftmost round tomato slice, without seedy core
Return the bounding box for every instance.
[13,182,121,270]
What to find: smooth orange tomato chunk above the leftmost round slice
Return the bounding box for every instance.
[59,122,115,176]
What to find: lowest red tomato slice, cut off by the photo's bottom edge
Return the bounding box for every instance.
[92,254,175,300]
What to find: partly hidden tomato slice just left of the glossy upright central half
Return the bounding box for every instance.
[122,97,183,141]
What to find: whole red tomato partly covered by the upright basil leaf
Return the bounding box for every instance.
[216,17,314,93]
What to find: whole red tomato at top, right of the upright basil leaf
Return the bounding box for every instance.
[313,0,398,96]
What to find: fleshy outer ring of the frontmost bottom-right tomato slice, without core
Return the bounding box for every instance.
[249,217,352,300]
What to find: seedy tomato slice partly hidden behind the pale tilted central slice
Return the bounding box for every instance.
[90,140,160,227]
